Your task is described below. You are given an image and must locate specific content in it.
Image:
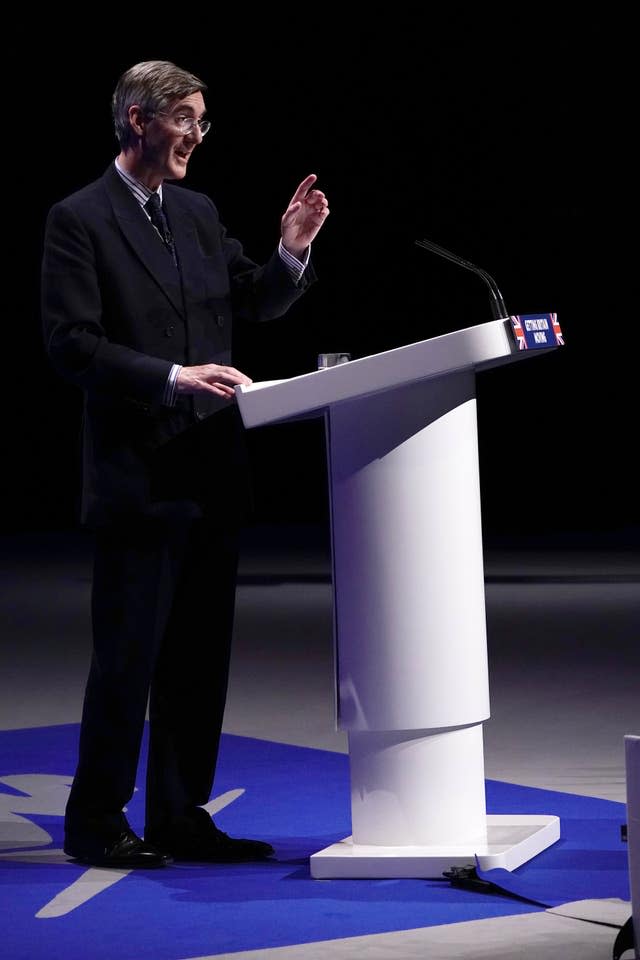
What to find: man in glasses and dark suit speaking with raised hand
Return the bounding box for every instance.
[42,61,328,868]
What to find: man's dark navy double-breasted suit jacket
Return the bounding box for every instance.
[42,164,315,524]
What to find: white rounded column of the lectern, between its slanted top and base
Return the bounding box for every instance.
[327,372,489,846]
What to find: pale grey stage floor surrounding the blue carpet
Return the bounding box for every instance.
[0,527,640,960]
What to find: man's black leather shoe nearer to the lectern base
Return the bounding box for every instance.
[145,811,274,863]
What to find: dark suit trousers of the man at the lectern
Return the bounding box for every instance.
[65,518,238,836]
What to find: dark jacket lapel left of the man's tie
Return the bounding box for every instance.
[104,166,184,316]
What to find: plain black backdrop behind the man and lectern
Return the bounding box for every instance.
[8,15,638,544]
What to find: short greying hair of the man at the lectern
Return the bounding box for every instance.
[111,60,207,149]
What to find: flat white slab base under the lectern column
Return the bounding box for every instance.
[310,814,560,880]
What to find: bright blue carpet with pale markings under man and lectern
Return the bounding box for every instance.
[0,725,629,960]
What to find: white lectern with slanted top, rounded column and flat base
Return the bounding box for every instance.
[236,320,560,879]
